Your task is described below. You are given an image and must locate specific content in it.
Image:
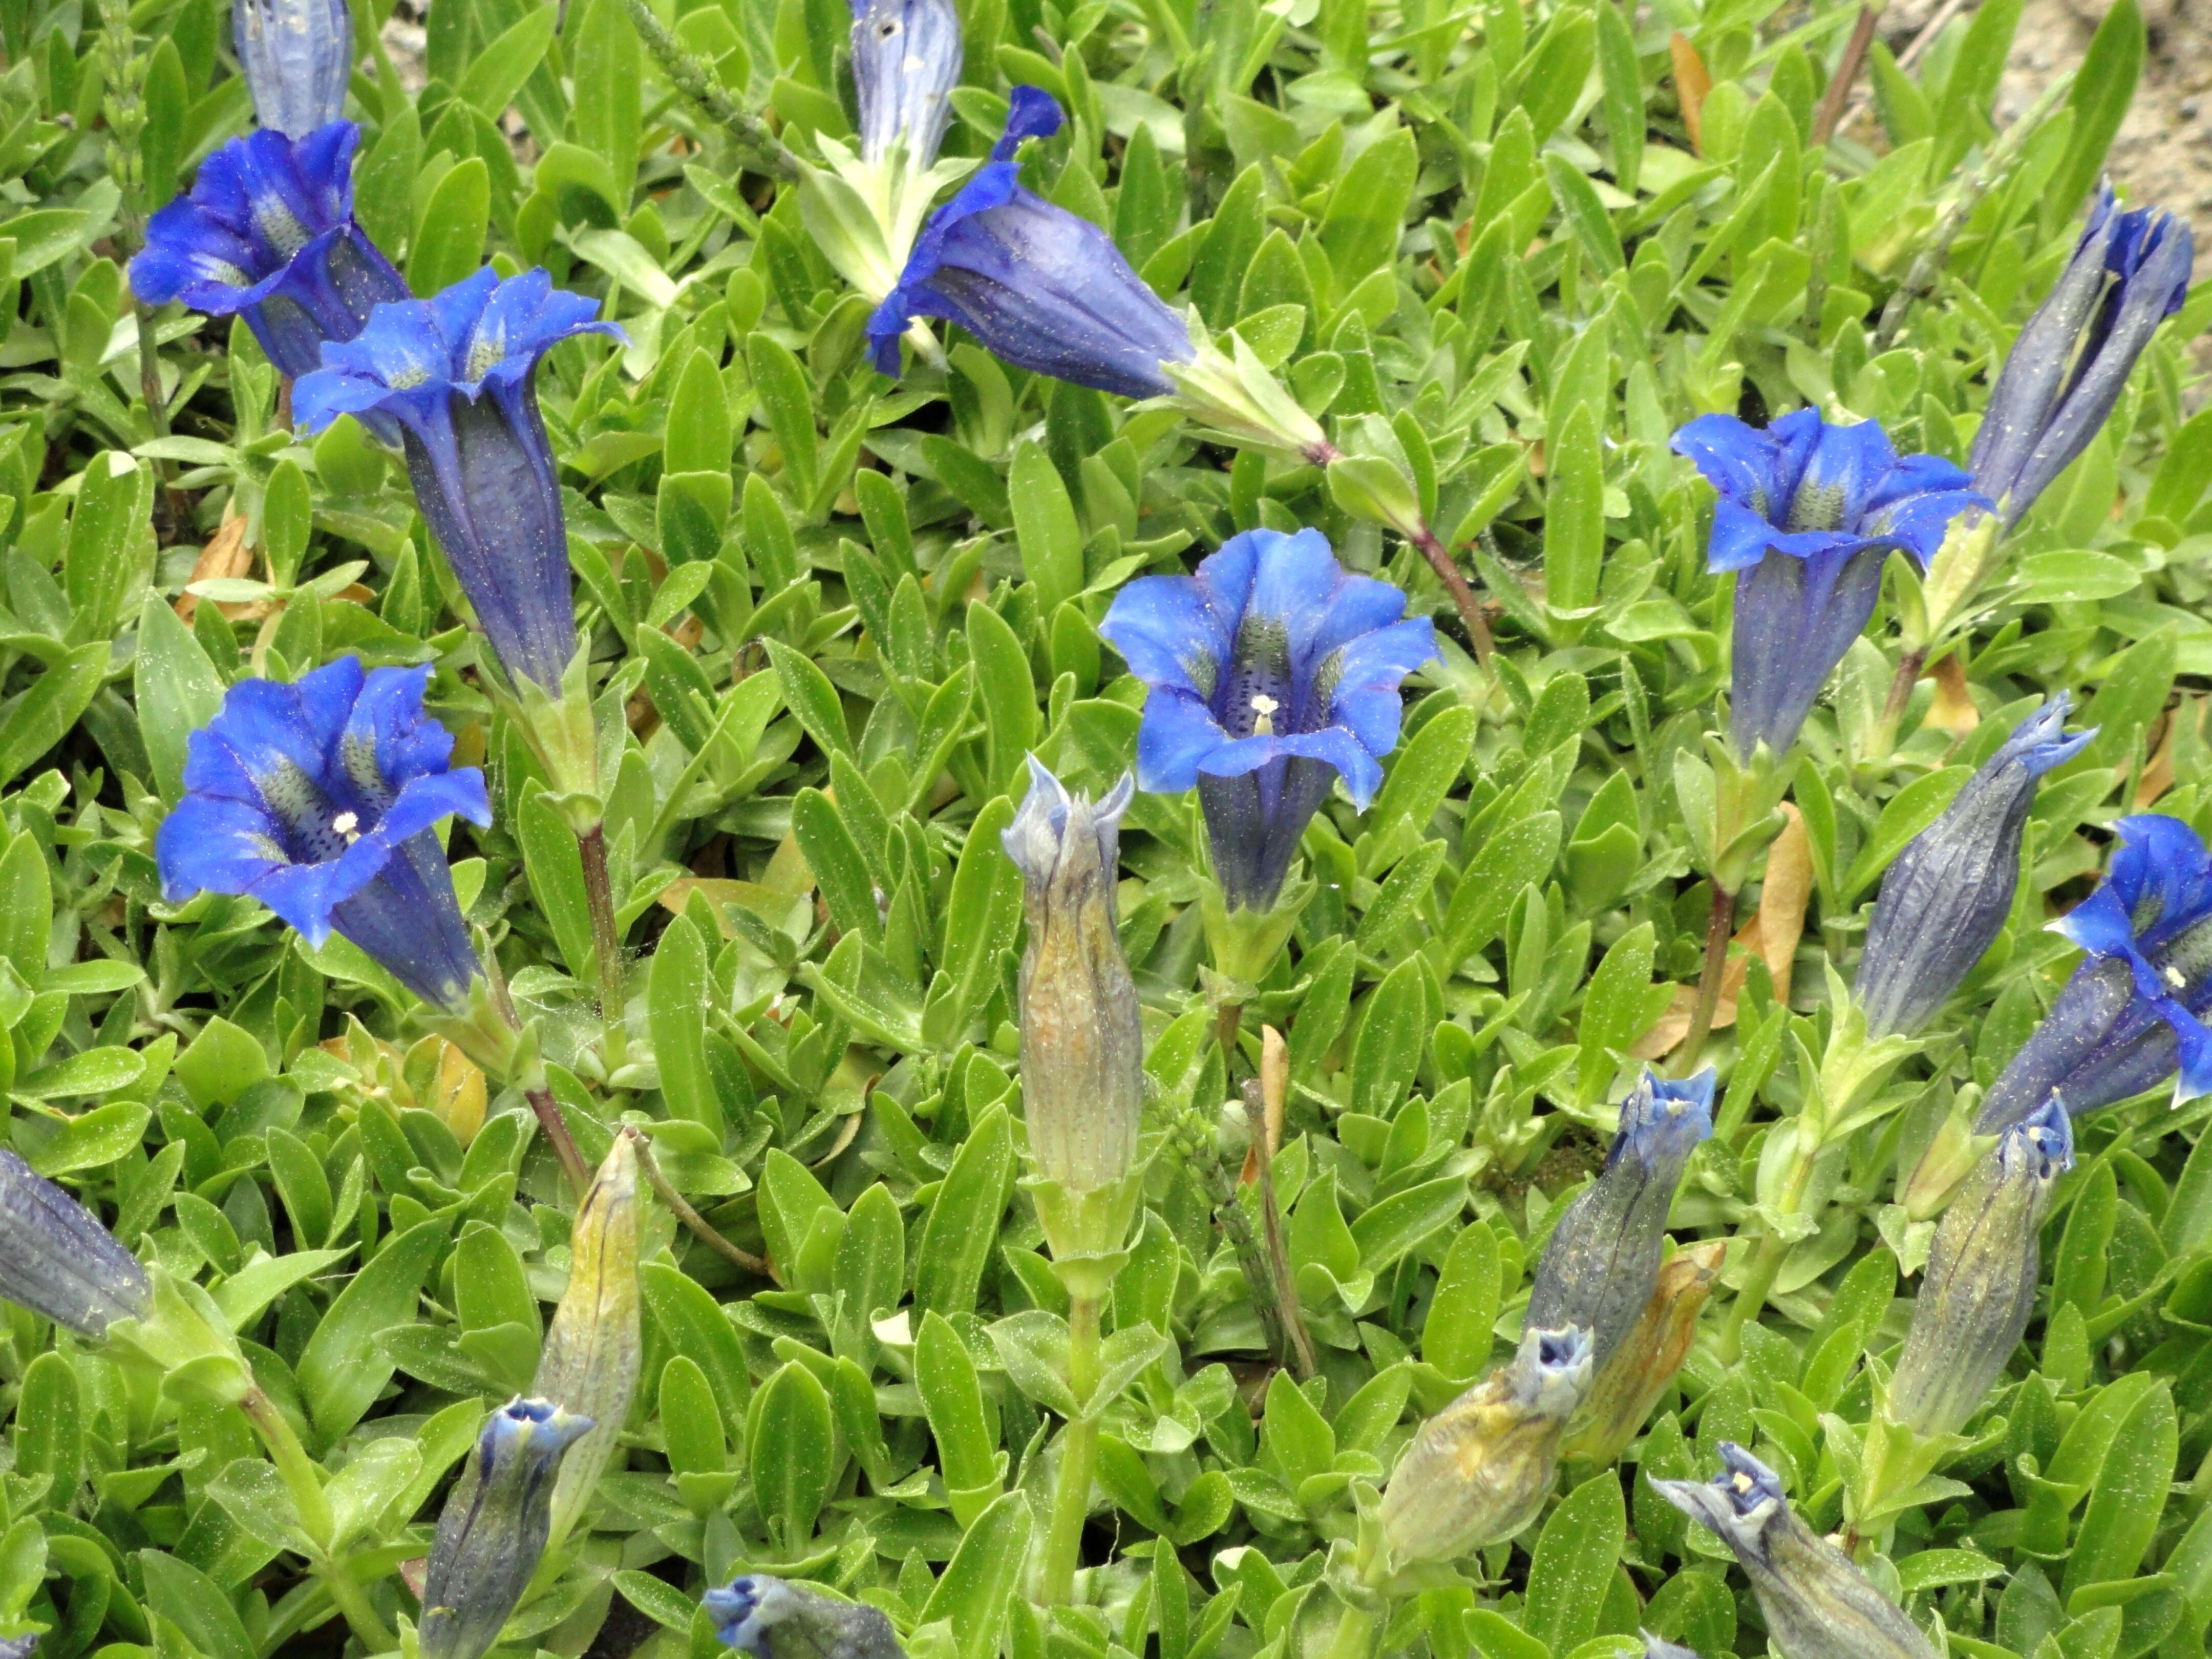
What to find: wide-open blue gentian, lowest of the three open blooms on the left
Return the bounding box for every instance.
[155,657,491,1013]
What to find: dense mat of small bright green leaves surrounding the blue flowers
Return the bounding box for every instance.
[0,0,2212,1659]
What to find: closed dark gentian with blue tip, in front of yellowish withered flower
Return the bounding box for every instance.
[422,1396,590,1659]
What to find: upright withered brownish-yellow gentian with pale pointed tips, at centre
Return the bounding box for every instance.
[1004,756,1143,1212]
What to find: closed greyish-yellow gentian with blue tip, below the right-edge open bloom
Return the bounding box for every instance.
[1889,1095,2073,1436]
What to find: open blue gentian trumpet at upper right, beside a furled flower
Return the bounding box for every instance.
[1674,409,1989,761]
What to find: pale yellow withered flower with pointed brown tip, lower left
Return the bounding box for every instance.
[533,1131,642,1542]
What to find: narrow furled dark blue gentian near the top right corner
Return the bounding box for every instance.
[1966,184,2194,528]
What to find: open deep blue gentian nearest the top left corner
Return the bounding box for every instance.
[131,122,407,380]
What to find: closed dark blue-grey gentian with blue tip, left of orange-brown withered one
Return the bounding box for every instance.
[1524,1066,1714,1371]
